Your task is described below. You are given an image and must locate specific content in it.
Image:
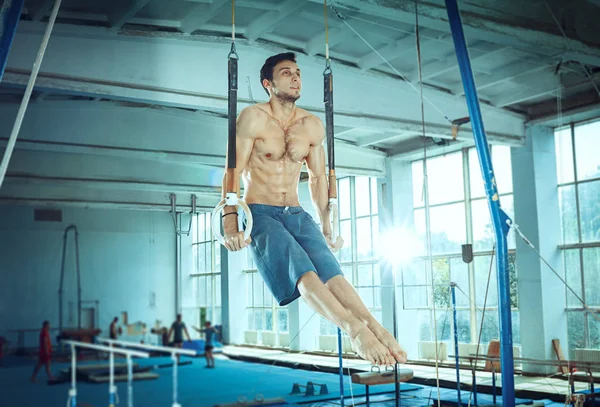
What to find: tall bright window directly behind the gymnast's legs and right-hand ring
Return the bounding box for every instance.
[320,177,381,335]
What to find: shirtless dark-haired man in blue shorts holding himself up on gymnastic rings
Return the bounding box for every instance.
[222,52,406,365]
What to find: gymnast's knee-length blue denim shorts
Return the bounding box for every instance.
[248,204,343,306]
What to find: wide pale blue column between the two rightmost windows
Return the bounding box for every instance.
[512,126,567,373]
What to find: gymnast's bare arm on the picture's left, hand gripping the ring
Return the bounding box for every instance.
[222,106,260,251]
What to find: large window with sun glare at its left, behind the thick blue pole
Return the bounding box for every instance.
[408,146,520,350]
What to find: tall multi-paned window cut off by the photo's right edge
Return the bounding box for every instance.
[555,121,600,350]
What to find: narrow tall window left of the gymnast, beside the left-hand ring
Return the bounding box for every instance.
[183,213,221,335]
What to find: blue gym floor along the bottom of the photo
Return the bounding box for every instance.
[0,348,585,407]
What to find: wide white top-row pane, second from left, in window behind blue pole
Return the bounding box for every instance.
[427,153,464,205]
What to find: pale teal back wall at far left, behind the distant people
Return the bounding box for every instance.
[0,206,176,346]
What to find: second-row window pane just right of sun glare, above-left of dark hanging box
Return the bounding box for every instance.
[430,203,466,255]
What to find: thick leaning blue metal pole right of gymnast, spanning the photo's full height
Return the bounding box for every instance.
[446,0,515,407]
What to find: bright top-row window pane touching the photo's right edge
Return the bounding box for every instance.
[575,121,600,181]
